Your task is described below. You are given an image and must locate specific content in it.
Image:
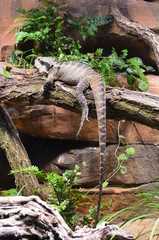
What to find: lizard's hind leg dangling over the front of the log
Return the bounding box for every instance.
[76,80,89,139]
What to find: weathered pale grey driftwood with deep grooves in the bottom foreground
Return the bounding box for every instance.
[0,196,133,240]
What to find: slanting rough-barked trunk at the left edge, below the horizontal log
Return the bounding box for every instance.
[0,106,40,196]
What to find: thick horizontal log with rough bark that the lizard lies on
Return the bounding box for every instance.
[0,64,159,129]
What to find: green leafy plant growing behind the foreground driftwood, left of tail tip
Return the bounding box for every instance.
[9,163,112,229]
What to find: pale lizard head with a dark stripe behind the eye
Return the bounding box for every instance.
[34,57,57,74]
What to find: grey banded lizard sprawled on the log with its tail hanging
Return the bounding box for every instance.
[35,57,106,227]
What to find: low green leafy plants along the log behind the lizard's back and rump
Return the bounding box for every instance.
[57,48,155,91]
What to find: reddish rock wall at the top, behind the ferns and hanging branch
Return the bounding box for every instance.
[0,0,159,63]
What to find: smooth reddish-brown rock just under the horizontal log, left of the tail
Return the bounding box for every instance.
[8,105,98,141]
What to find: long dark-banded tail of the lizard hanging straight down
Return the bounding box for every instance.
[90,74,106,227]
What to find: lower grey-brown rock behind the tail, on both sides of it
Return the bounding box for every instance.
[47,145,159,187]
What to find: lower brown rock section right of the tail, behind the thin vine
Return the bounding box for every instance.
[106,144,159,185]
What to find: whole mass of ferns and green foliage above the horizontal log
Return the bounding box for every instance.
[8,0,154,91]
